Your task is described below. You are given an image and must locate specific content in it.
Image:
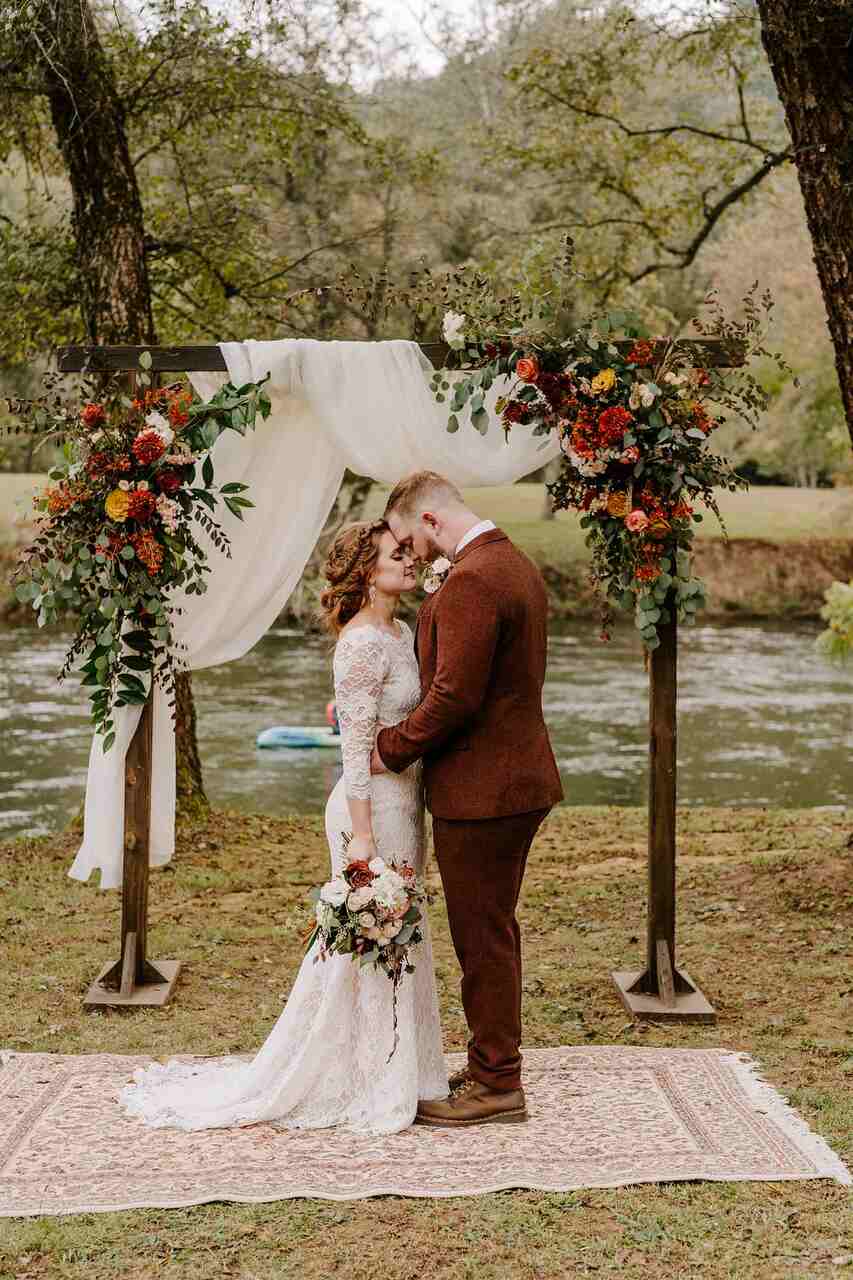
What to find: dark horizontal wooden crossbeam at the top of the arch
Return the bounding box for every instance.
[58,338,744,374]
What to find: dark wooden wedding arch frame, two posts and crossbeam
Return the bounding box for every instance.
[58,339,742,1023]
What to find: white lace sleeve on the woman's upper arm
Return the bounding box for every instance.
[334,627,388,800]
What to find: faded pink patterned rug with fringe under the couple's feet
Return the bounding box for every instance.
[0,1047,850,1217]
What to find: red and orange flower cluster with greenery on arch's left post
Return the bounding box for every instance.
[10,352,270,751]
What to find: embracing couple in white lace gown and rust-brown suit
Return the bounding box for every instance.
[120,472,562,1134]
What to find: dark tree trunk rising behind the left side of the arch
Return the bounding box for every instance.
[29,0,209,817]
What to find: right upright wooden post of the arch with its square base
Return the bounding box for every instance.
[613,596,716,1023]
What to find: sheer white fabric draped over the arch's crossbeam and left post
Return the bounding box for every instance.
[69,339,558,888]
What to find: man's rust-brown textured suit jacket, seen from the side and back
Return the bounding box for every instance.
[377,529,562,819]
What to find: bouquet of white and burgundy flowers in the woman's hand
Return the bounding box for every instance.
[307,837,427,1061]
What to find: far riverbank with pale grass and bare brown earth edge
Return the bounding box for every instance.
[0,475,853,626]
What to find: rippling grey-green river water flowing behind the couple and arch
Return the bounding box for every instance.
[0,622,853,836]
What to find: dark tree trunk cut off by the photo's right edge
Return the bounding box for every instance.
[757,0,853,440]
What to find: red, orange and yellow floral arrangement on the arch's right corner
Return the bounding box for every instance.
[433,296,783,650]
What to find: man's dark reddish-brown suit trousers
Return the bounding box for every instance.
[433,809,548,1089]
